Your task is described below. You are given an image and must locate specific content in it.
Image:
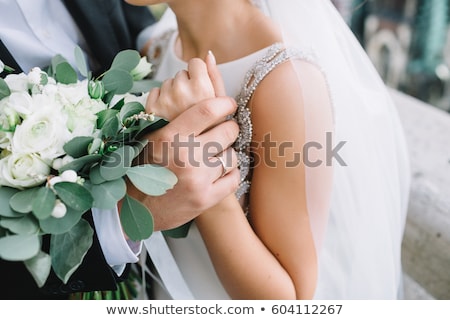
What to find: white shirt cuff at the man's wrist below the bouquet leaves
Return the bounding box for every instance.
[92,207,142,276]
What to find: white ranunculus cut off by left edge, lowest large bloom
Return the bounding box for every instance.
[0,154,50,189]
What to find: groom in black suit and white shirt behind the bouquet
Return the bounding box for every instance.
[0,0,238,299]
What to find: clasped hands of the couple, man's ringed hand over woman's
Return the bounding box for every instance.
[127,53,239,230]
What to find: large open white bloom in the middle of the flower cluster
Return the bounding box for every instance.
[11,106,70,161]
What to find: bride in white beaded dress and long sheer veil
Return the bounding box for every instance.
[127,0,409,299]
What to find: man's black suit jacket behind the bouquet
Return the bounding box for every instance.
[0,0,155,299]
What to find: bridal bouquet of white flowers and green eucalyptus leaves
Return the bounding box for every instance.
[0,48,177,286]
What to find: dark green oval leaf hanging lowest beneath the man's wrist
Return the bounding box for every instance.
[120,196,153,241]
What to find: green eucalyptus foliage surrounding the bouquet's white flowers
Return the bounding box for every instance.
[0,47,177,287]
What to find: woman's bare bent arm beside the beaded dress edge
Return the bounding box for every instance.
[196,62,331,299]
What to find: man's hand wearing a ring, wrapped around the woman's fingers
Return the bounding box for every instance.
[128,97,240,230]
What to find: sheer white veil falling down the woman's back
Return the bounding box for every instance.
[253,0,410,298]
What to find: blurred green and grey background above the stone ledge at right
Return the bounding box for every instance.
[332,0,450,112]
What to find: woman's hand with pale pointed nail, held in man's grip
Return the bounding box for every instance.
[145,54,224,121]
